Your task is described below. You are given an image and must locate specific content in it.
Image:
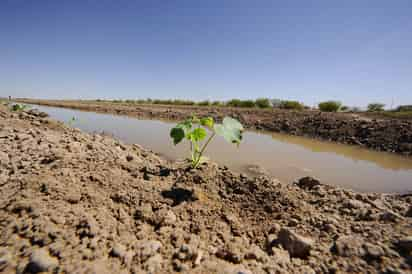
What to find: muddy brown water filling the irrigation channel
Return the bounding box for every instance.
[27,106,412,193]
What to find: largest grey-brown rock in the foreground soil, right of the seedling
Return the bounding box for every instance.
[277,228,313,258]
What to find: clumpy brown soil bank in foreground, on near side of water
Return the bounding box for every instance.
[0,106,412,274]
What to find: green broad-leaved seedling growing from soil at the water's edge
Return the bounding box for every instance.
[170,117,243,168]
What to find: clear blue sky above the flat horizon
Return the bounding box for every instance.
[0,0,412,106]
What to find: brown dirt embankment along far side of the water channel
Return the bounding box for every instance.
[14,99,412,155]
